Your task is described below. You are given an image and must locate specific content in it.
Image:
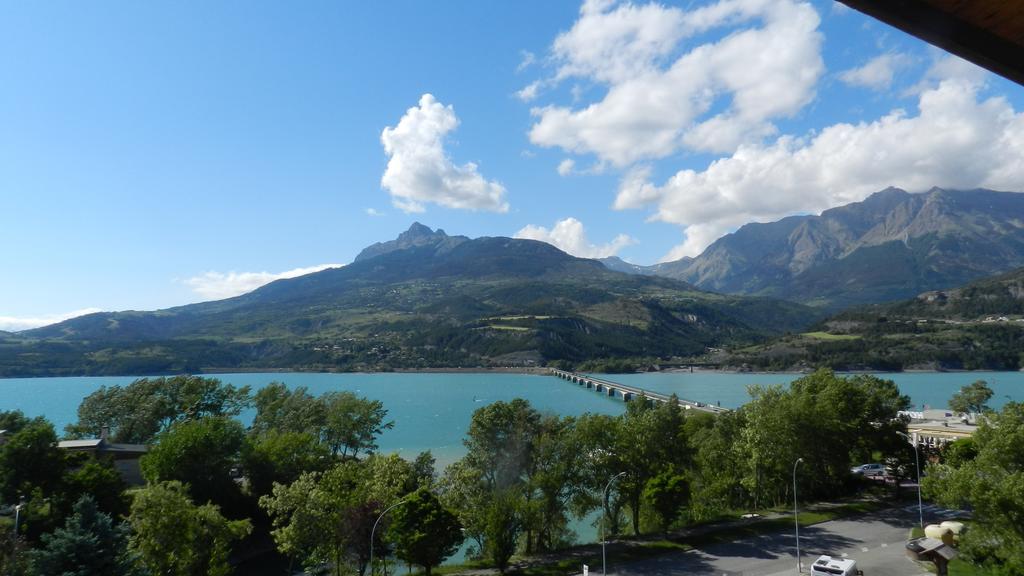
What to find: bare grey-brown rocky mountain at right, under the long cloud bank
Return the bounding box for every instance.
[602,188,1024,310]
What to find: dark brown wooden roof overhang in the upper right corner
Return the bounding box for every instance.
[839,0,1024,84]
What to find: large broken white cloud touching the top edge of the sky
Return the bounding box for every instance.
[521,0,824,167]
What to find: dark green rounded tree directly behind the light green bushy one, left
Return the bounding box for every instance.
[140,416,245,509]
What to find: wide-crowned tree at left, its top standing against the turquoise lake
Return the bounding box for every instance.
[66,375,251,444]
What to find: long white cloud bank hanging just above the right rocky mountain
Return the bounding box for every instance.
[615,56,1024,259]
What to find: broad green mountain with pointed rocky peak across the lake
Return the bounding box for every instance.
[0,224,815,374]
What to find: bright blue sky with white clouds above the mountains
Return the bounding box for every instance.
[0,0,1024,330]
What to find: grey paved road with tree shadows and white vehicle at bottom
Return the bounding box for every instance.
[591,505,956,576]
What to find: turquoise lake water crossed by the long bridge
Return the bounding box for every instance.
[0,372,1024,562]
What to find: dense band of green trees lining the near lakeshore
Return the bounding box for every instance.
[0,371,933,575]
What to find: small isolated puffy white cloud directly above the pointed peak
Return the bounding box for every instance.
[381,94,509,212]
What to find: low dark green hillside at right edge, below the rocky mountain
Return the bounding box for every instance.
[726,269,1024,370]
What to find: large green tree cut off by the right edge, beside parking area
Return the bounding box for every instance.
[924,402,1024,576]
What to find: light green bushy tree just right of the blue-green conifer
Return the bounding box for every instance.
[128,482,252,576]
